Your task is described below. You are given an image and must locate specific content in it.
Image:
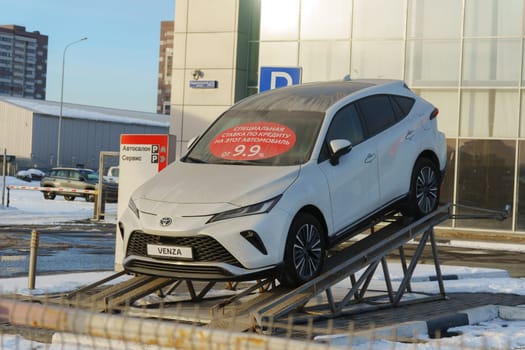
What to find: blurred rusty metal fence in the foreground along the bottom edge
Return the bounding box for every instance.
[0,294,525,350]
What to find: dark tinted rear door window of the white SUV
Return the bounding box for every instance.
[357,95,397,136]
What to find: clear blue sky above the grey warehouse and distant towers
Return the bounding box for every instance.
[0,0,175,113]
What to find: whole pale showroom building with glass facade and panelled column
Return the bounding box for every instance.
[170,0,525,233]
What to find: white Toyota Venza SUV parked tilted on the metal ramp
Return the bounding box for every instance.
[119,80,446,286]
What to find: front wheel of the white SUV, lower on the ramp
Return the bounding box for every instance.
[279,213,326,287]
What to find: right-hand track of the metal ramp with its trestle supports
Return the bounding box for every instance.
[214,205,450,327]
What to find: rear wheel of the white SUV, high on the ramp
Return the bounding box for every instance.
[404,158,441,218]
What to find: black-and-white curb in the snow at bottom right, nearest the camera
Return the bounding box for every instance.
[315,305,525,347]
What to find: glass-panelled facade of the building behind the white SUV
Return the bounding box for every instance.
[259,0,525,233]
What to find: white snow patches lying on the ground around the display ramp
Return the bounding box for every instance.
[0,177,525,350]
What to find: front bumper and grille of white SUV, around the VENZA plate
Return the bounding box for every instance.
[119,208,291,281]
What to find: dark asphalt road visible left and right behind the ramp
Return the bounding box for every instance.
[0,220,525,277]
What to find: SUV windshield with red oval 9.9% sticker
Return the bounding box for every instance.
[182,109,324,165]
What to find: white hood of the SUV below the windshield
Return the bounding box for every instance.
[133,161,301,207]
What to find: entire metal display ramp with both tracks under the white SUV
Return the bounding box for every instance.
[21,205,451,330]
